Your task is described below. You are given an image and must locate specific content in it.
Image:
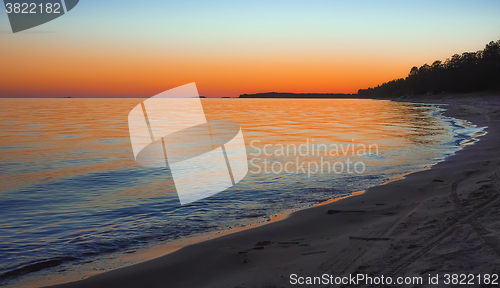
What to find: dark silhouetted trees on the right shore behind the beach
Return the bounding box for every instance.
[358,40,500,98]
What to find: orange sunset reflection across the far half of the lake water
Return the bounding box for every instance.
[0,99,451,194]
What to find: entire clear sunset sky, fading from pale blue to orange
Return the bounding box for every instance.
[0,0,500,97]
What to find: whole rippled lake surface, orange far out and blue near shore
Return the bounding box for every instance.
[0,99,482,283]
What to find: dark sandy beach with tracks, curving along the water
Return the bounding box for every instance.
[47,95,500,288]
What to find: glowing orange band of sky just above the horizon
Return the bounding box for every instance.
[0,38,454,97]
